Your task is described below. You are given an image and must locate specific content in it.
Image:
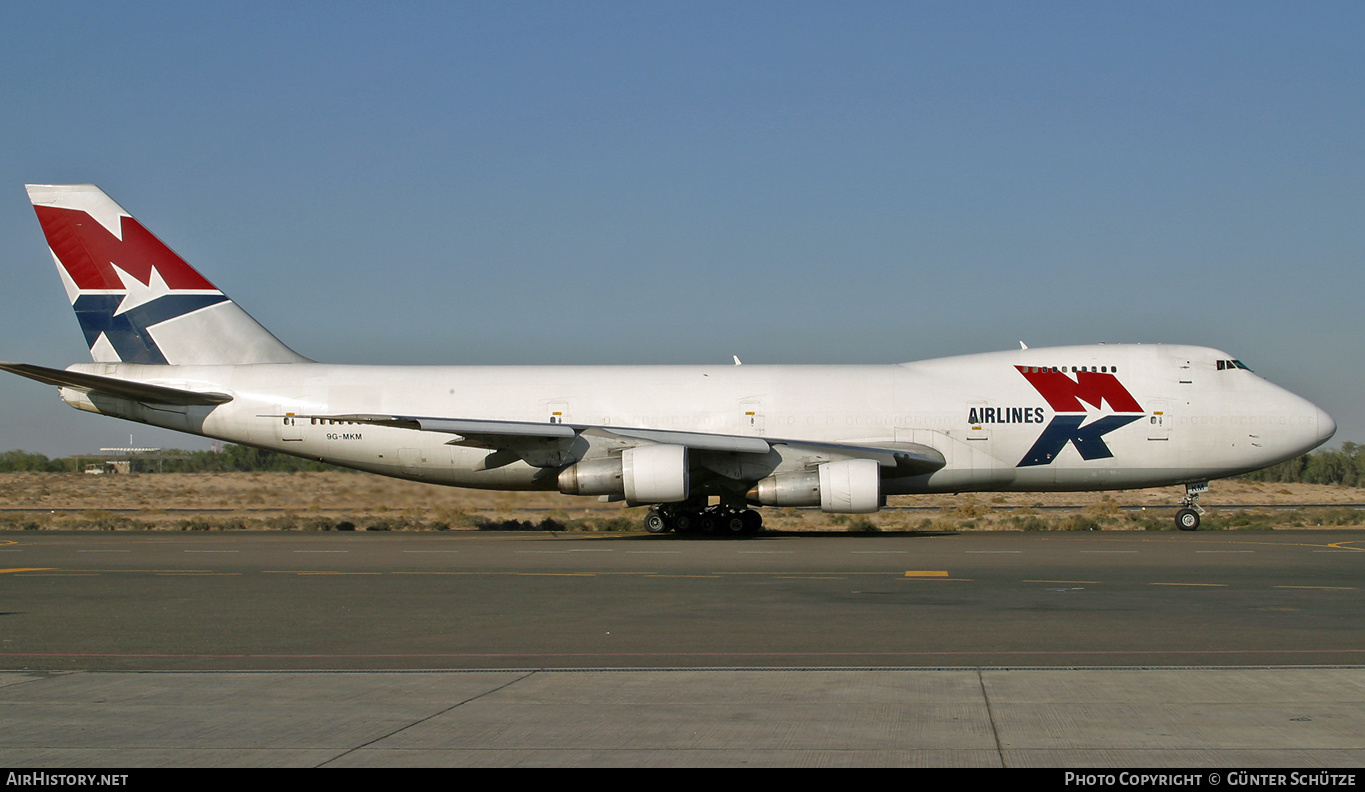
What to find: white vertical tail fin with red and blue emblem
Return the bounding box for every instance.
[27,184,307,366]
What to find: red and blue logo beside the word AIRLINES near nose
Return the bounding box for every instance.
[1014,366,1144,467]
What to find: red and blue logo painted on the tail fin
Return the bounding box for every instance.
[33,198,228,365]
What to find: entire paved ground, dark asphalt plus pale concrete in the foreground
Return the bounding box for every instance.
[0,531,1365,767]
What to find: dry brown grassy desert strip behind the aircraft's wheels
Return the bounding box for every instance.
[0,471,1365,531]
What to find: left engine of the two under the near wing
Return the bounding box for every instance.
[558,445,689,504]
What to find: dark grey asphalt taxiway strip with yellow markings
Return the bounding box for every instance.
[0,531,1365,670]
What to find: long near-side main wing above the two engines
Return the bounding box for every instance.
[299,414,946,475]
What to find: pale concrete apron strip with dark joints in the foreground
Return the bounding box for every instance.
[0,669,1365,770]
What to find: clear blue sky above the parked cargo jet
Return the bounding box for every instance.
[0,0,1365,455]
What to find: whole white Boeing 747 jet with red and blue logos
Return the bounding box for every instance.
[0,184,1336,533]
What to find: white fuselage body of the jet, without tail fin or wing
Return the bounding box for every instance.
[63,344,1335,494]
